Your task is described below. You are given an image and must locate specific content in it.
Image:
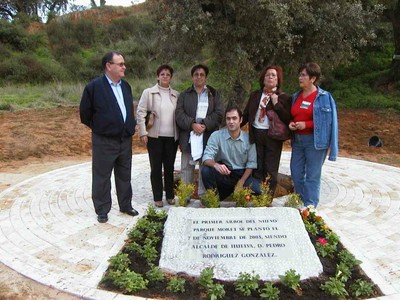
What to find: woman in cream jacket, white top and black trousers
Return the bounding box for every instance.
[137,65,179,207]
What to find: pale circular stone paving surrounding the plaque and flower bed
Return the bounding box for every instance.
[0,152,400,299]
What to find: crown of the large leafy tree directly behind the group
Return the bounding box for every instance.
[147,0,382,102]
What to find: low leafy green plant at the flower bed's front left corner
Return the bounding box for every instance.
[107,270,148,293]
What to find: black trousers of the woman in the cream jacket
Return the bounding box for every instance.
[147,136,178,201]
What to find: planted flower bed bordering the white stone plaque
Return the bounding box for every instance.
[100,206,382,300]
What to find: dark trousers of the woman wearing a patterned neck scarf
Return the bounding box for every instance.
[253,128,283,195]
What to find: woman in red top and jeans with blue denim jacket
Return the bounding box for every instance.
[289,63,338,207]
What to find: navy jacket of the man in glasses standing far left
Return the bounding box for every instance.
[80,75,136,137]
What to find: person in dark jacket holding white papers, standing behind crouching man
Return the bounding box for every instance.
[175,64,224,196]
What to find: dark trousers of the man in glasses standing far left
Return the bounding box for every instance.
[92,133,132,215]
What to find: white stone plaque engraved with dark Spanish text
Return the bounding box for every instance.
[159,207,322,281]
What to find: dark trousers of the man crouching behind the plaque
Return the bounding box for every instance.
[201,166,261,200]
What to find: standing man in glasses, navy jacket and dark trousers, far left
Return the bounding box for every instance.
[80,51,138,223]
